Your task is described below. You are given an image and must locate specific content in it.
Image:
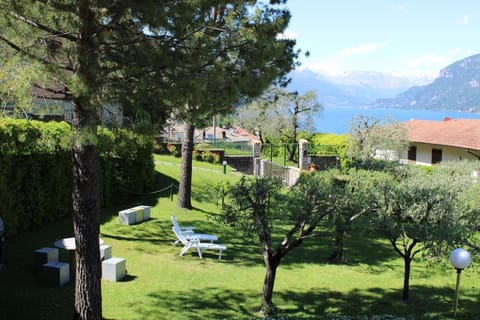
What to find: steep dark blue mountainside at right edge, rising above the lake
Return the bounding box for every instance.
[370,54,480,112]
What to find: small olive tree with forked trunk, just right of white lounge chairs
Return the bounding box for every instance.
[218,171,344,315]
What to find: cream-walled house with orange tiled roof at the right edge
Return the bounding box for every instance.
[402,118,480,165]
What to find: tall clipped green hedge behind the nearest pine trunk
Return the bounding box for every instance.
[0,118,154,235]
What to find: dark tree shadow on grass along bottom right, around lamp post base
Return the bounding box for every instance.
[274,286,480,319]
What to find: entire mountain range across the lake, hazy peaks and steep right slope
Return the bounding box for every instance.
[290,54,480,112]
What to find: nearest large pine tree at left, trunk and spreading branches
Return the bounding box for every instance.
[0,0,175,320]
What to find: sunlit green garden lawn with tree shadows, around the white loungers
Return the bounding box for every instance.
[0,156,480,320]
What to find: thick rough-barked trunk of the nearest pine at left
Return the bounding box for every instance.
[72,0,102,320]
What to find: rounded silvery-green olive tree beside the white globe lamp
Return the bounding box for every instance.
[371,166,474,301]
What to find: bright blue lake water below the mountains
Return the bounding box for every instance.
[314,107,480,134]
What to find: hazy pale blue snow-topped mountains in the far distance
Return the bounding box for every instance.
[289,69,432,107]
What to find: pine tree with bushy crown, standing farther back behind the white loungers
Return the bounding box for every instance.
[158,0,298,208]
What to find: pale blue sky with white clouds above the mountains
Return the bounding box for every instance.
[285,0,480,77]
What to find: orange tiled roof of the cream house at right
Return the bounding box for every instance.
[406,118,480,150]
